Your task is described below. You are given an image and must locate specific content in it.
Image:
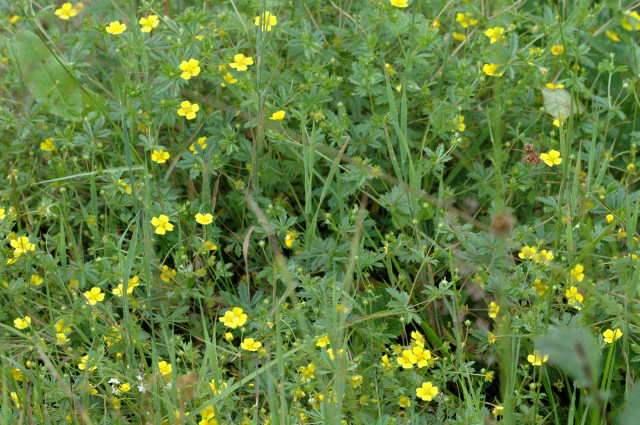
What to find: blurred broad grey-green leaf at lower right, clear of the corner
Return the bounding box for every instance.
[536,328,601,388]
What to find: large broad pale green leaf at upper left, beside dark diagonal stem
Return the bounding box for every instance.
[16,31,82,121]
